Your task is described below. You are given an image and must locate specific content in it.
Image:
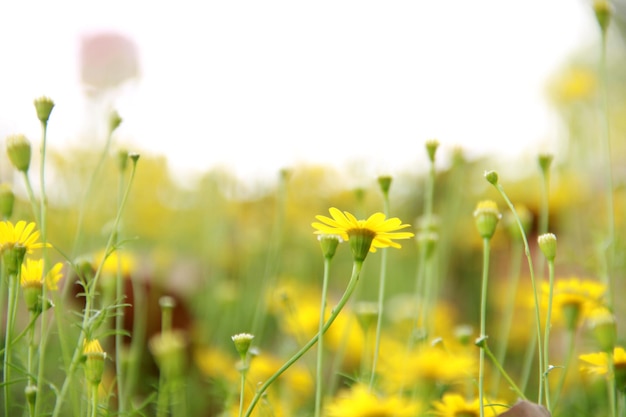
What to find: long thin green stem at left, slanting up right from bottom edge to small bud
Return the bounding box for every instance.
[51,159,137,417]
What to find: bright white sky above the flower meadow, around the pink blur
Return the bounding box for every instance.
[0,0,596,182]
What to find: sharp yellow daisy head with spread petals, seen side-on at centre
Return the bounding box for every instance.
[311,207,414,261]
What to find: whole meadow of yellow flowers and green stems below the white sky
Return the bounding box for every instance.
[0,2,626,417]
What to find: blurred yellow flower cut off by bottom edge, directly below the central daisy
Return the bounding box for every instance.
[324,384,419,417]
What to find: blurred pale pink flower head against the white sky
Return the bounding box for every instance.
[80,32,139,91]
